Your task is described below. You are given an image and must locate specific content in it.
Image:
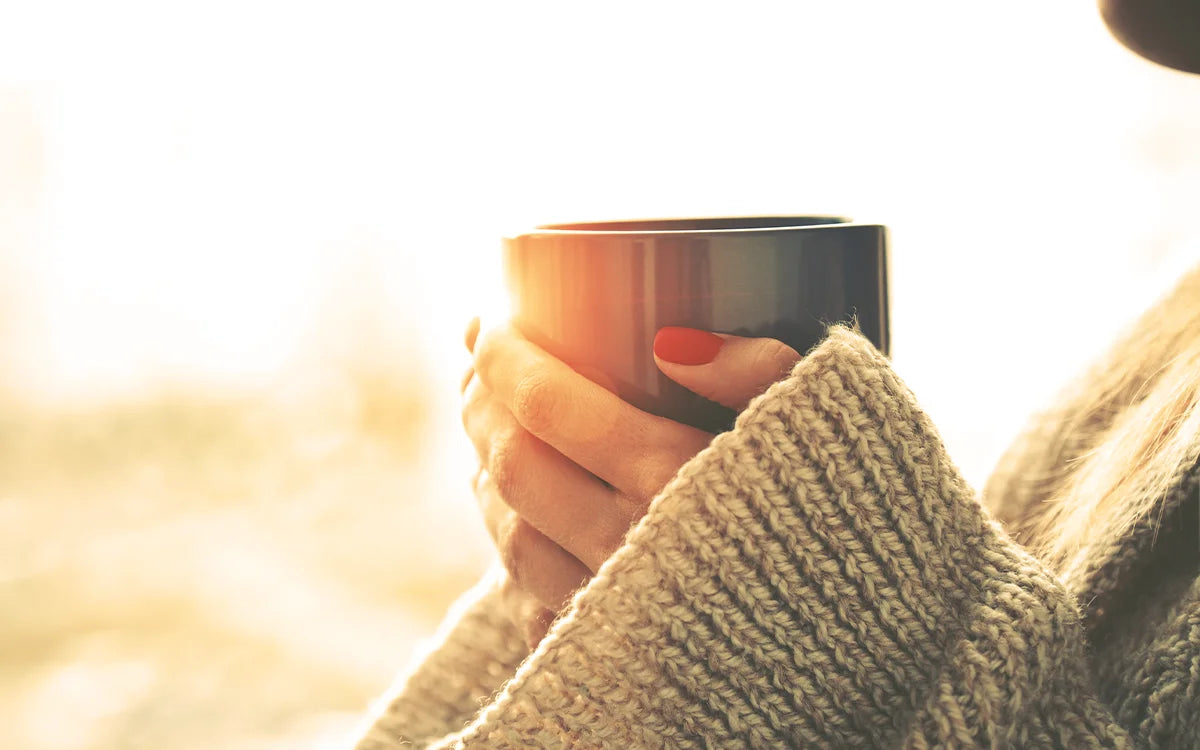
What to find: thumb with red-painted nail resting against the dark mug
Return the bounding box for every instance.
[654,328,800,412]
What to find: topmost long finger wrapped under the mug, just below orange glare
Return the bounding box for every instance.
[475,325,712,498]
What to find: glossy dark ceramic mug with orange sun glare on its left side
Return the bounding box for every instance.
[504,216,889,432]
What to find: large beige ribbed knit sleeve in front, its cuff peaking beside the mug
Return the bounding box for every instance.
[417,329,1132,749]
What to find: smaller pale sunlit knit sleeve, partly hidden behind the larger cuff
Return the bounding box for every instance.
[355,571,529,750]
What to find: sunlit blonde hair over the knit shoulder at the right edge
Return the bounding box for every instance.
[985,268,1200,574]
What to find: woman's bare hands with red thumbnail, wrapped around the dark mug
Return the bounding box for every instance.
[462,320,799,646]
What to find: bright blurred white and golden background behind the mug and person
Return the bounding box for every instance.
[0,0,1200,750]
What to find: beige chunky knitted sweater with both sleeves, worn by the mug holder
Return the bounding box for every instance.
[358,329,1200,750]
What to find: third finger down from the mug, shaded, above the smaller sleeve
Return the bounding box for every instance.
[475,474,592,612]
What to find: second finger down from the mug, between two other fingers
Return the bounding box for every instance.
[466,400,628,572]
